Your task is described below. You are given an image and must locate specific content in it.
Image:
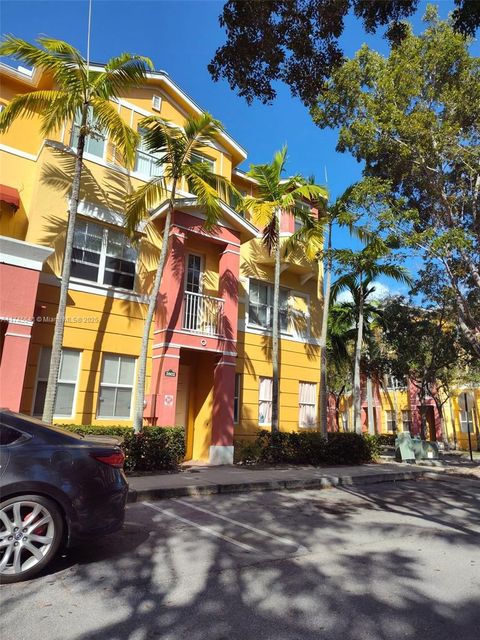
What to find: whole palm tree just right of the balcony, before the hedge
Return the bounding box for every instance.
[244,147,327,432]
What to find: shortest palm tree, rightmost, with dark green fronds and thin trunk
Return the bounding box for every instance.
[332,239,412,433]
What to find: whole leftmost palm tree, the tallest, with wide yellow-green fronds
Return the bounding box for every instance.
[0,36,153,423]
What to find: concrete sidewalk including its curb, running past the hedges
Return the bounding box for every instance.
[128,463,437,502]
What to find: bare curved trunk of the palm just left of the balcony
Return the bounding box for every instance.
[133,191,175,433]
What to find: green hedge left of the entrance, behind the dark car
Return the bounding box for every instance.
[59,424,185,473]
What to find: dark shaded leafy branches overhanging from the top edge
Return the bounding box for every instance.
[209,0,480,106]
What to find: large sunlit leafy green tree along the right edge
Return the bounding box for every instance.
[312,10,480,356]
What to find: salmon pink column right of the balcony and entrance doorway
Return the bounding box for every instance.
[210,244,240,465]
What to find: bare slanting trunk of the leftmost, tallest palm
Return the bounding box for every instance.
[42,103,89,424]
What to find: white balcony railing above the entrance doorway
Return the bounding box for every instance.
[183,291,224,336]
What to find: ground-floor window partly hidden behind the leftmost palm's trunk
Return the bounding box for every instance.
[33,347,80,417]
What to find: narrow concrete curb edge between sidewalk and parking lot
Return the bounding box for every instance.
[128,469,428,503]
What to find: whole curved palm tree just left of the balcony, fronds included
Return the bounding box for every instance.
[126,113,239,433]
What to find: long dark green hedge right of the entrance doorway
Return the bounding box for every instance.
[236,431,380,466]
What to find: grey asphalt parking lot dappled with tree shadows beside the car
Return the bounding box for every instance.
[0,477,480,640]
